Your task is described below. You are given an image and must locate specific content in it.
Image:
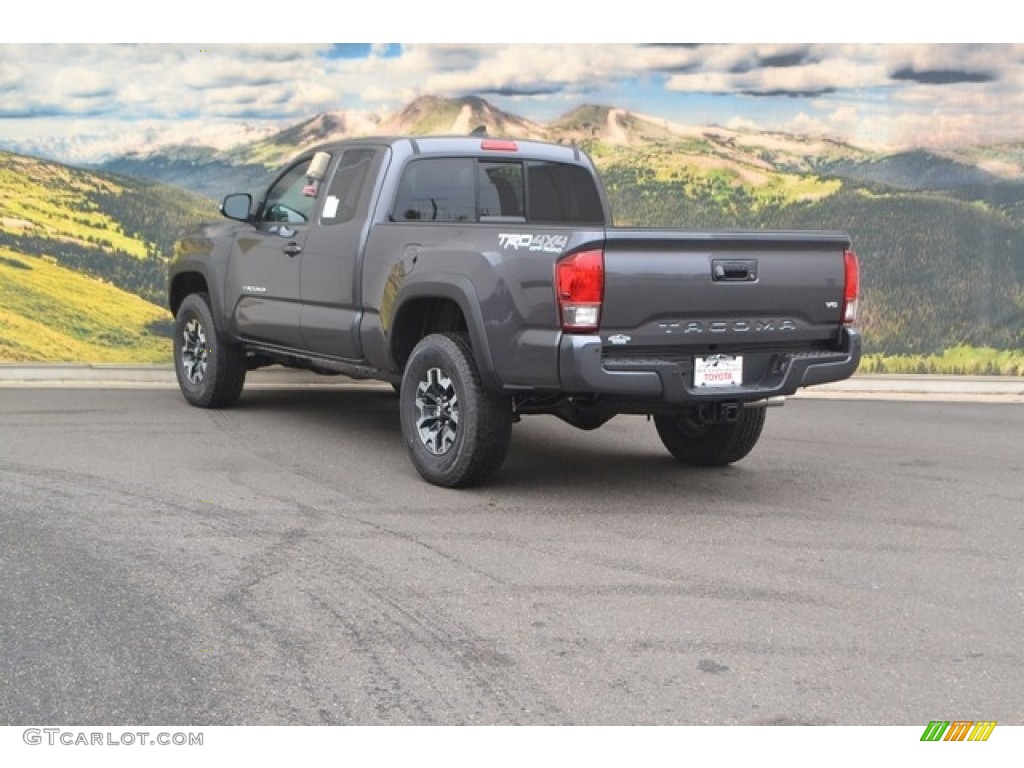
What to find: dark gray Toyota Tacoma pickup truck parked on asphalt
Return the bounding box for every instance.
[169,136,860,487]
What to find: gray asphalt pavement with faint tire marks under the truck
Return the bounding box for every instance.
[0,380,1024,728]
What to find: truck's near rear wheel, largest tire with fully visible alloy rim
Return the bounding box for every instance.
[398,333,512,487]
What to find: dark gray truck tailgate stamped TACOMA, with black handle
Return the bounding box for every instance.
[600,228,850,351]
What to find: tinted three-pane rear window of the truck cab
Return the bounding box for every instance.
[391,158,604,224]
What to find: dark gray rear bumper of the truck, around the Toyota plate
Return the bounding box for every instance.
[558,329,861,403]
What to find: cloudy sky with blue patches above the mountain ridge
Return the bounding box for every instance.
[0,37,1024,161]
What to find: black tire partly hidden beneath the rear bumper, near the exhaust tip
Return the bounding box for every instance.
[654,408,765,467]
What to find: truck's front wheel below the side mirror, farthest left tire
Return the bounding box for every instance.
[174,293,247,408]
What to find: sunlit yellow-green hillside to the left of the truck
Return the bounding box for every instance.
[0,152,216,362]
